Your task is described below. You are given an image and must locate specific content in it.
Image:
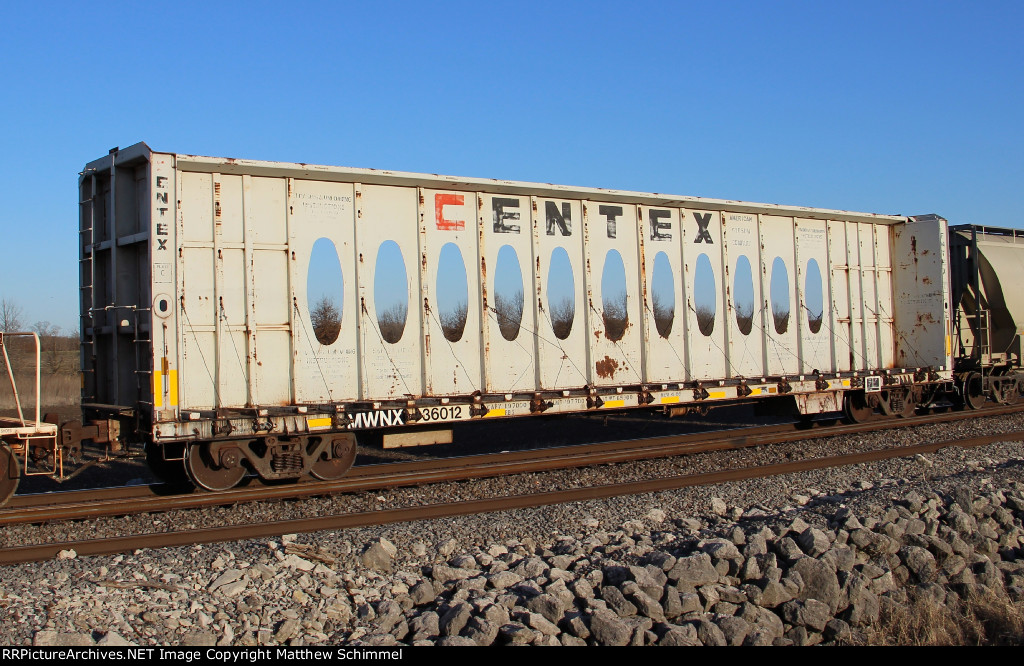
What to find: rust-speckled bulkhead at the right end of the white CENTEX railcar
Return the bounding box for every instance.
[893,217,952,370]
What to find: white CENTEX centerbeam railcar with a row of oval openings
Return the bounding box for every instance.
[11,143,1024,504]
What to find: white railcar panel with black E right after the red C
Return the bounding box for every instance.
[477,194,537,393]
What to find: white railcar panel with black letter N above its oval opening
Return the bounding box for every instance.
[532,198,591,389]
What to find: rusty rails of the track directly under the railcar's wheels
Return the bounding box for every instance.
[0,406,1024,526]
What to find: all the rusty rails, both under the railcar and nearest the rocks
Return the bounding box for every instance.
[0,406,1024,564]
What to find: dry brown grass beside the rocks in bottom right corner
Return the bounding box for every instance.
[866,595,1024,646]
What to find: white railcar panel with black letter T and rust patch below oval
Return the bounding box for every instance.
[583,201,643,386]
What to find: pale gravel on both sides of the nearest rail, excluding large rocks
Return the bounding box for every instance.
[0,415,1024,644]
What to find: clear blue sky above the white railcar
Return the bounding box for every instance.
[0,1,1024,327]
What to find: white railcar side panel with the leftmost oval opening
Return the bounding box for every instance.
[288,180,359,404]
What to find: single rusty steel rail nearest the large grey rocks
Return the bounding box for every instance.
[0,430,1024,565]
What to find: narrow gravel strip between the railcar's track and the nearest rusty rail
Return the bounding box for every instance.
[0,414,1024,547]
